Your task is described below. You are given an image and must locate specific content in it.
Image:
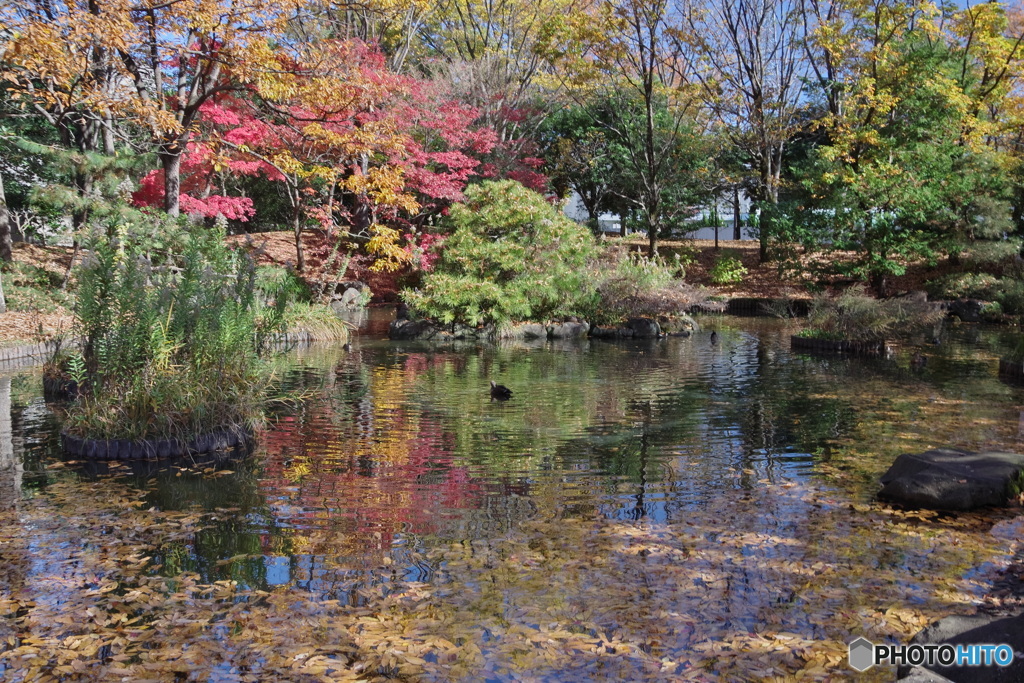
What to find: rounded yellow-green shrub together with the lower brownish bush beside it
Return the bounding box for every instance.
[402,180,706,326]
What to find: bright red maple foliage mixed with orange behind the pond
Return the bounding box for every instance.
[133,41,548,248]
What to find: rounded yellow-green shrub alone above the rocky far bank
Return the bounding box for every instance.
[402,180,597,326]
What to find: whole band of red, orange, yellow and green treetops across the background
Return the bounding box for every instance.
[0,0,1024,282]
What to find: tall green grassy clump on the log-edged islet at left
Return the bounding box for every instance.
[66,224,289,439]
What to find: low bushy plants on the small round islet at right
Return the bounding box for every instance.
[802,285,945,341]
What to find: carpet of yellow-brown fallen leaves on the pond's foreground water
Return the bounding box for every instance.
[0,480,1021,681]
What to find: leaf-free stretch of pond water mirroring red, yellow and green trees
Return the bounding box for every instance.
[0,318,1024,630]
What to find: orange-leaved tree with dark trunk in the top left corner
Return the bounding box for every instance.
[0,0,302,215]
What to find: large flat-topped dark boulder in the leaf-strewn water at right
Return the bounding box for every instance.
[879,449,1024,510]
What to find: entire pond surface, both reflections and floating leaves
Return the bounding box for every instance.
[0,317,1024,681]
